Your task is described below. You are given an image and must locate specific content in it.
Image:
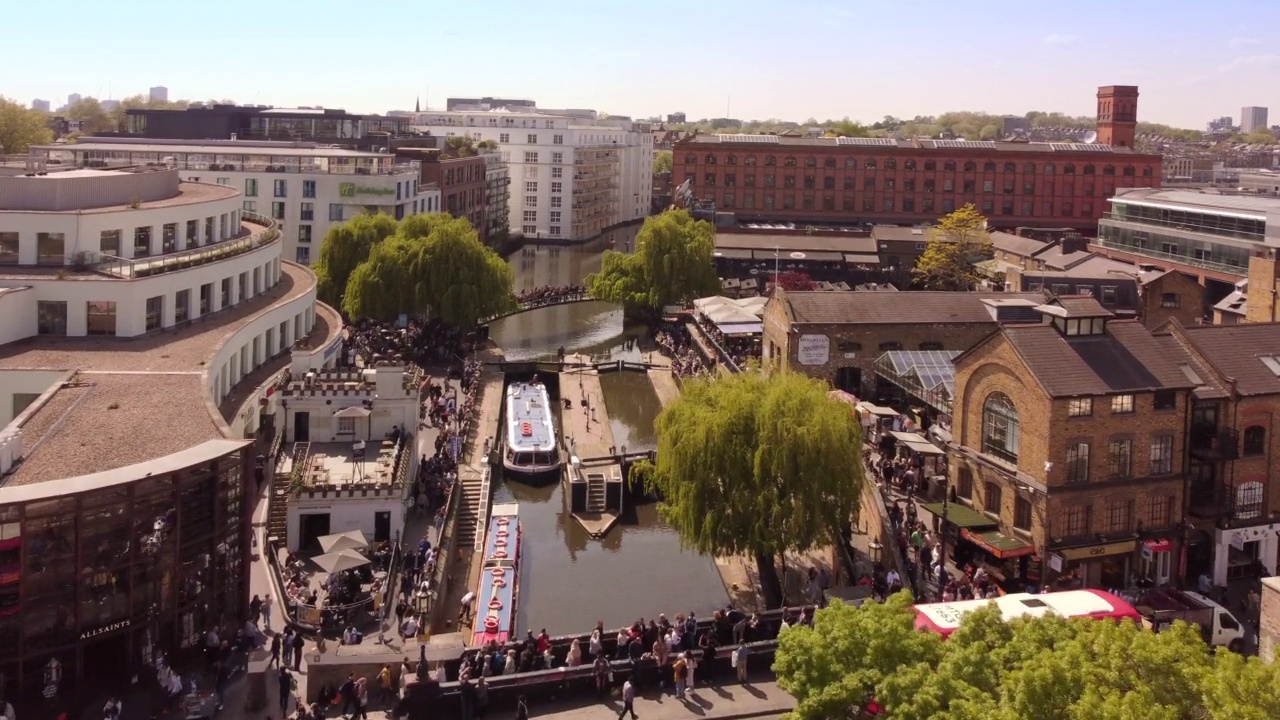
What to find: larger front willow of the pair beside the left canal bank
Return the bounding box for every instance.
[342,214,515,328]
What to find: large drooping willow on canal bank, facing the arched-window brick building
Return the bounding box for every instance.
[637,372,864,606]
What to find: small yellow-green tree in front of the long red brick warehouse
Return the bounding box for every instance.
[911,204,992,290]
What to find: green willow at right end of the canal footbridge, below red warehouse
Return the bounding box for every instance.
[586,210,719,314]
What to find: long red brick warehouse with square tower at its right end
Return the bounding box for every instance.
[673,86,1161,233]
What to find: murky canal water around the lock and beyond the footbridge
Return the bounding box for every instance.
[489,228,728,635]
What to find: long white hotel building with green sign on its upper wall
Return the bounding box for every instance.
[33,137,440,265]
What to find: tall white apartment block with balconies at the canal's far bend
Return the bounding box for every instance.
[413,108,653,240]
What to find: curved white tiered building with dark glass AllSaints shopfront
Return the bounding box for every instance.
[0,159,345,697]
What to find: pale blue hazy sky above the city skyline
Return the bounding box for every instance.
[10,0,1280,128]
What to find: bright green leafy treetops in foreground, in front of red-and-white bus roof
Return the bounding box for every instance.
[773,592,1280,720]
